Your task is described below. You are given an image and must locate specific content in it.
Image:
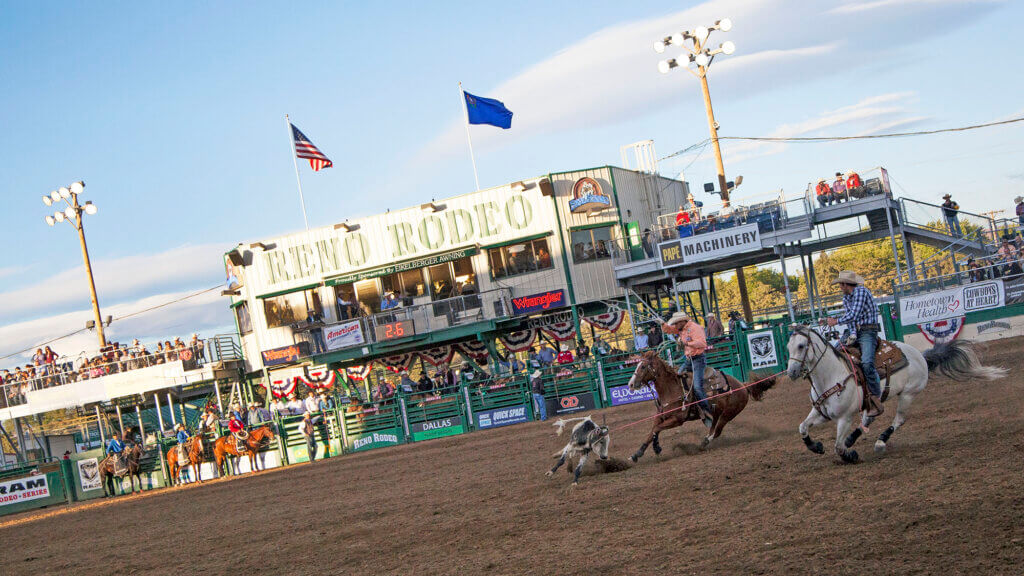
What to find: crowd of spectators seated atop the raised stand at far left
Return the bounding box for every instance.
[0,334,206,408]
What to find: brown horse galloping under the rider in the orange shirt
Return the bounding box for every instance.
[630,344,775,462]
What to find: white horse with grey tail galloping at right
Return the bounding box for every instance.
[787,325,1007,463]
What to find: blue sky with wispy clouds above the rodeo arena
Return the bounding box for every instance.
[0,0,1024,364]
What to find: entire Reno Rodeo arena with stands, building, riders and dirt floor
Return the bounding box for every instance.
[0,14,1024,574]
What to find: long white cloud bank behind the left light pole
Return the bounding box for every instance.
[0,244,225,322]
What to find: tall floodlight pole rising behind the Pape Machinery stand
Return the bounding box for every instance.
[654,18,753,322]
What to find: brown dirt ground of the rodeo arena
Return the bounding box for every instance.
[0,339,1024,576]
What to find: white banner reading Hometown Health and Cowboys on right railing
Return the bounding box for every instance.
[899,280,1006,326]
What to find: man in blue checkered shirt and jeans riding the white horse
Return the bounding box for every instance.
[825,270,885,418]
